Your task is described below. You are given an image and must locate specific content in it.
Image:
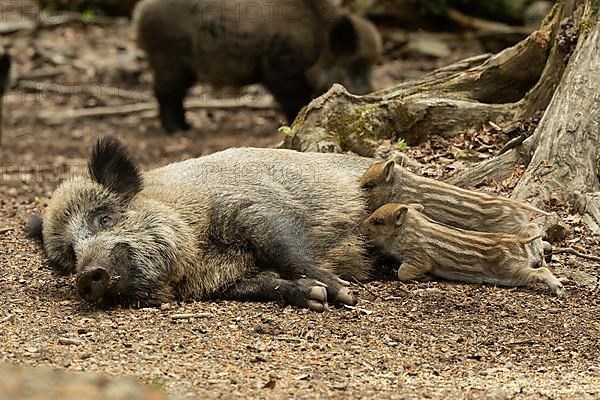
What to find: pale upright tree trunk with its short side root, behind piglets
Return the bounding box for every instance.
[449,2,600,234]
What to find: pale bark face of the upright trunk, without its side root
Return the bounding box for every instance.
[513,14,600,212]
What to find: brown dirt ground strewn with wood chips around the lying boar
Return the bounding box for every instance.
[0,1,600,399]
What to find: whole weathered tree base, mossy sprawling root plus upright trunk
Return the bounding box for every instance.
[284,0,600,233]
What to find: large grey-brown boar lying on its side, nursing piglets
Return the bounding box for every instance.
[34,138,372,311]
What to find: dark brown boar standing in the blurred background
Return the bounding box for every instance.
[134,0,382,132]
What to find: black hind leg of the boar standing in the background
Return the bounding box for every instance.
[154,68,196,133]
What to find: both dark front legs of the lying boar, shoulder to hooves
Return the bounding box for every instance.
[212,206,355,310]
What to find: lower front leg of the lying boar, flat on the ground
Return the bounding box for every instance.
[221,271,346,312]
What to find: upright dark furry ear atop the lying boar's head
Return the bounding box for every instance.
[88,136,143,197]
